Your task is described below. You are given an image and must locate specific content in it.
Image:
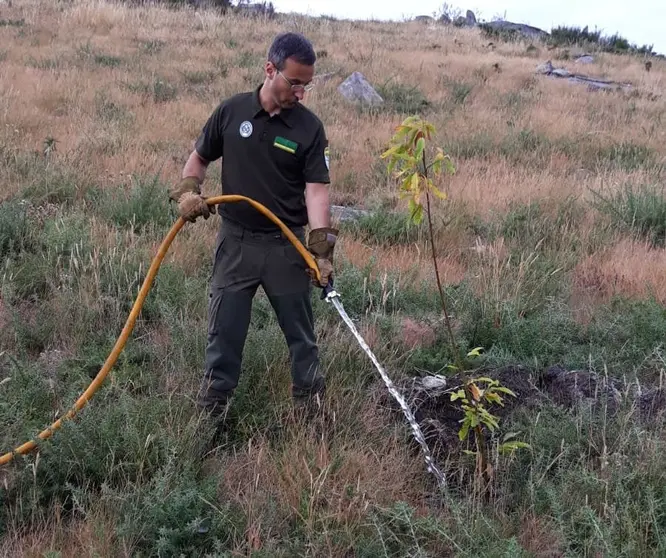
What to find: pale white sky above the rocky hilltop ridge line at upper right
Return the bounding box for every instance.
[272,0,666,54]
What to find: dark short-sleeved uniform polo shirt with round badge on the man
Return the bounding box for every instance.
[196,86,330,231]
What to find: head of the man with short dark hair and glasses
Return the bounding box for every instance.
[264,33,316,109]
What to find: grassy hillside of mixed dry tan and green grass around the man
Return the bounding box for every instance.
[0,0,666,558]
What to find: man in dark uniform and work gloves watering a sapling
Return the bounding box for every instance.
[170,33,338,430]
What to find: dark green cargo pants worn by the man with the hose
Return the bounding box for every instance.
[198,221,325,415]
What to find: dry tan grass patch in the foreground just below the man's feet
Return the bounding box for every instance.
[215,402,425,556]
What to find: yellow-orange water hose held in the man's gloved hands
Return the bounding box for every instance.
[0,195,321,465]
